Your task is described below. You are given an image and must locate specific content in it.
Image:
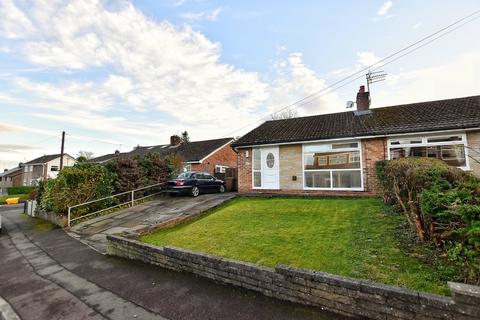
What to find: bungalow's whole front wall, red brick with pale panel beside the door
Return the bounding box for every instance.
[238,138,387,195]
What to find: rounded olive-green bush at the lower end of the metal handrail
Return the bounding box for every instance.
[40,163,115,215]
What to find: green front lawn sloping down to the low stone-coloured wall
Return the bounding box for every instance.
[141,198,454,294]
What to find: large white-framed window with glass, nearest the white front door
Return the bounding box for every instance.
[302,141,363,191]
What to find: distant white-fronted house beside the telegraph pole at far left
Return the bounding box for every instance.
[19,154,76,186]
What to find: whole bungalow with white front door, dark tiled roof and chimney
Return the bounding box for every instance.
[232,86,480,195]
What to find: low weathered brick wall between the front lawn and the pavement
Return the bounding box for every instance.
[107,235,480,320]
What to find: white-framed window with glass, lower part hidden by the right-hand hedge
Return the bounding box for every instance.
[388,133,470,170]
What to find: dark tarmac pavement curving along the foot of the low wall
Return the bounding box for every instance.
[0,206,343,320]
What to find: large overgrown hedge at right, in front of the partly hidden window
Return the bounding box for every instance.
[377,158,480,284]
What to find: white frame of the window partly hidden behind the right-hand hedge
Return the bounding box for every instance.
[387,132,470,171]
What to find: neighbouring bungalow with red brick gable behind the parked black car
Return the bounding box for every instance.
[90,135,237,175]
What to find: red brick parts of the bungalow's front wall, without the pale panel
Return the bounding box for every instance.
[237,138,387,196]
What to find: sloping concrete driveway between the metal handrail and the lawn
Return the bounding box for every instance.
[69,193,236,253]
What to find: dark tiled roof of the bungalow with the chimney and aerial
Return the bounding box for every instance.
[232,96,480,147]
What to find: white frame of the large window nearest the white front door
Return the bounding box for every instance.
[302,140,365,191]
